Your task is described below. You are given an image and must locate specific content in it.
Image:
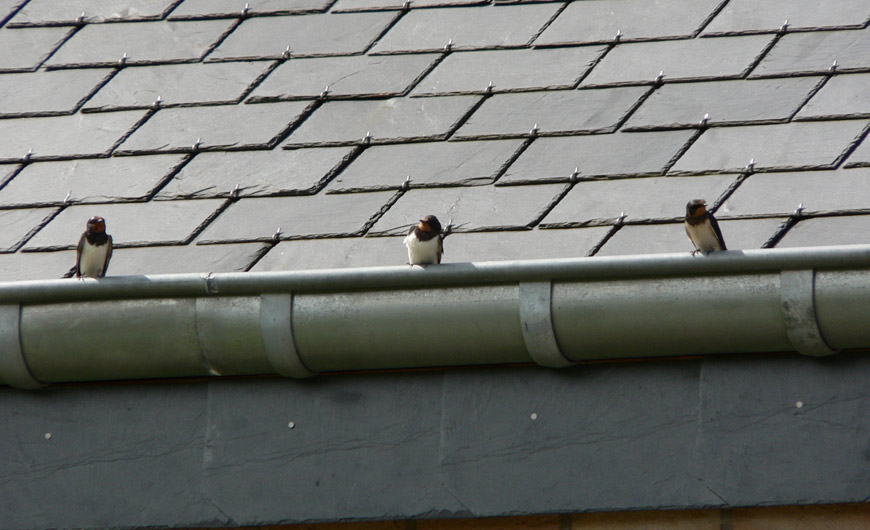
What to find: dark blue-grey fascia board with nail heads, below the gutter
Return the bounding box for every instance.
[0,355,870,529]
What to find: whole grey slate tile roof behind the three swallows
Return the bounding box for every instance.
[0,0,870,280]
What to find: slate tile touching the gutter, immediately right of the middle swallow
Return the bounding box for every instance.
[444,226,610,263]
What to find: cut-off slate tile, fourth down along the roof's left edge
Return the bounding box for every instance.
[0,111,145,160]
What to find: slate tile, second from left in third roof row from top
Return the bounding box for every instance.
[85,62,268,111]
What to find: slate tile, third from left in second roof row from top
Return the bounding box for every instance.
[209,12,397,60]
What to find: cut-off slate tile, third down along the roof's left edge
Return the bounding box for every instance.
[0,68,112,116]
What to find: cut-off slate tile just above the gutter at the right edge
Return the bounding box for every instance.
[776,215,870,248]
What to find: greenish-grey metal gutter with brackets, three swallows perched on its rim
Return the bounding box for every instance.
[0,245,870,388]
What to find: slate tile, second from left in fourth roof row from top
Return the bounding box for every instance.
[117,101,308,152]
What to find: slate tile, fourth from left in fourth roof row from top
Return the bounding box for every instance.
[456,87,648,138]
